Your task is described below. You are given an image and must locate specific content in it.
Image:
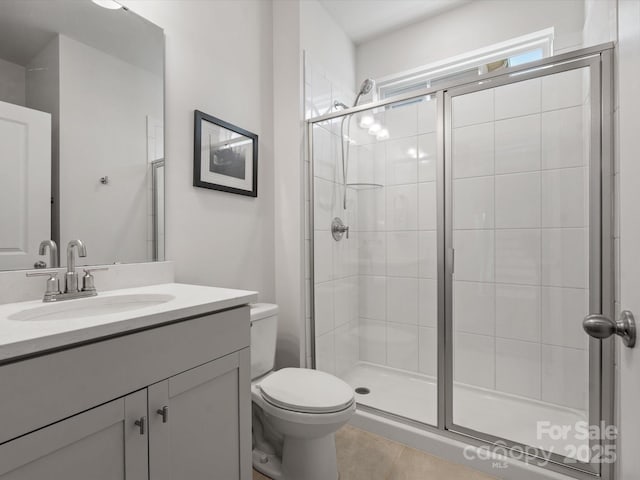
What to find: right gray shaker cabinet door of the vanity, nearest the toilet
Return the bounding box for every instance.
[149,348,251,480]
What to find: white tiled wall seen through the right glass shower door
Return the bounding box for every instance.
[452,69,590,409]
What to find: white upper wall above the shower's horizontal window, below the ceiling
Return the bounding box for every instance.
[356,0,584,78]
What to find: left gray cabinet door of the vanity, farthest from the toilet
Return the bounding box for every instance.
[0,390,148,480]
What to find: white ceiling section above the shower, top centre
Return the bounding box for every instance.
[320,0,471,44]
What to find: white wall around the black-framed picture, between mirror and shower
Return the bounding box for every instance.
[124,0,275,301]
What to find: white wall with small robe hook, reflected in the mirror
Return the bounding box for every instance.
[59,35,163,265]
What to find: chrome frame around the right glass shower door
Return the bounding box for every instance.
[439,49,614,479]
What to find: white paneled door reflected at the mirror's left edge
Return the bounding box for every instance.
[0,102,51,270]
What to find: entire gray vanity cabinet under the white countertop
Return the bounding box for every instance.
[0,307,251,480]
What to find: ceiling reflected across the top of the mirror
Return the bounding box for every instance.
[0,0,164,75]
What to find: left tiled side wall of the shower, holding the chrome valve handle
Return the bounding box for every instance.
[304,56,359,375]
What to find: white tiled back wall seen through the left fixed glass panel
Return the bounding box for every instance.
[349,99,437,376]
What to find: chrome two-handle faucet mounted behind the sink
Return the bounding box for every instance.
[26,240,108,302]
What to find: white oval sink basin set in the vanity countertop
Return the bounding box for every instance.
[8,293,175,322]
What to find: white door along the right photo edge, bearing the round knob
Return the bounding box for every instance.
[616,0,640,480]
